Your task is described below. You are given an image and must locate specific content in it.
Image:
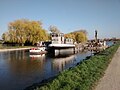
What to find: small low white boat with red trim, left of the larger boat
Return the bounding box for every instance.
[29,47,47,55]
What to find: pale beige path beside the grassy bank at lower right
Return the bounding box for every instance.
[95,47,120,90]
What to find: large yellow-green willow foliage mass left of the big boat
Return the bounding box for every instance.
[2,19,48,45]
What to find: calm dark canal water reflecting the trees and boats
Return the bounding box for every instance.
[0,50,91,90]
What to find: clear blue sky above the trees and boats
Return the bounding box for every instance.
[0,0,120,39]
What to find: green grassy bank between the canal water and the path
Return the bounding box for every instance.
[32,44,119,90]
